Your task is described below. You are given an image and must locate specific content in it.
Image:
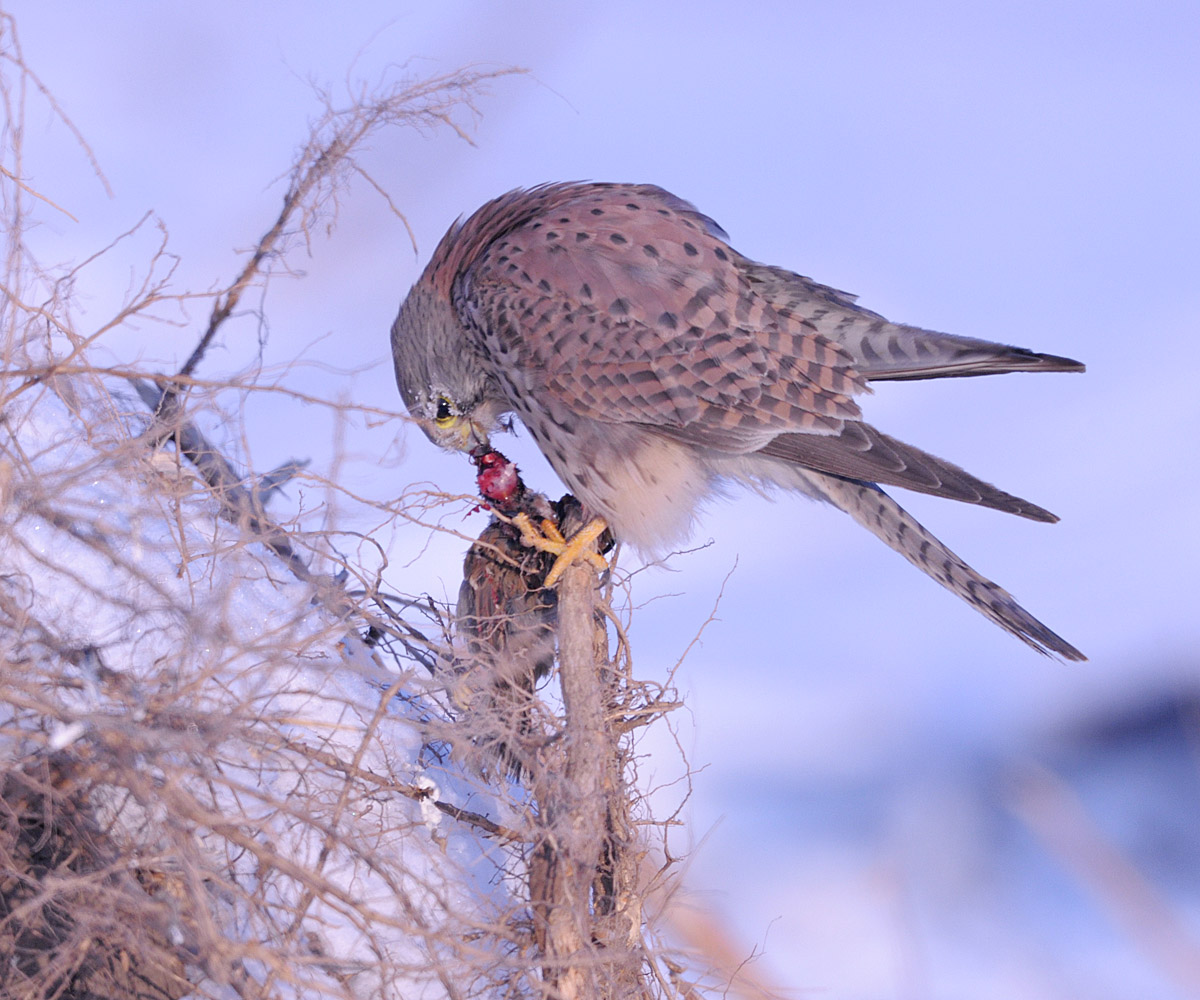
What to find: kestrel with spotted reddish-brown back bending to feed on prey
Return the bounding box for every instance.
[391,184,1084,660]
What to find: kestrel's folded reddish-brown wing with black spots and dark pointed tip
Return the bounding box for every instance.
[464,185,1055,520]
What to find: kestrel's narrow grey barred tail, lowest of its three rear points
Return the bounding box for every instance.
[794,468,1087,660]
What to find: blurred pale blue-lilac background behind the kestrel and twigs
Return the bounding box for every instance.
[11,0,1200,1000]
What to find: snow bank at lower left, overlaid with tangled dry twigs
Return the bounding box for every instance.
[0,369,514,998]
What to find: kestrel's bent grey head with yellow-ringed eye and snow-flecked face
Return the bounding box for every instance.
[391,279,508,451]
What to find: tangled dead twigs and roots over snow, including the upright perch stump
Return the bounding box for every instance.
[0,16,777,1000]
